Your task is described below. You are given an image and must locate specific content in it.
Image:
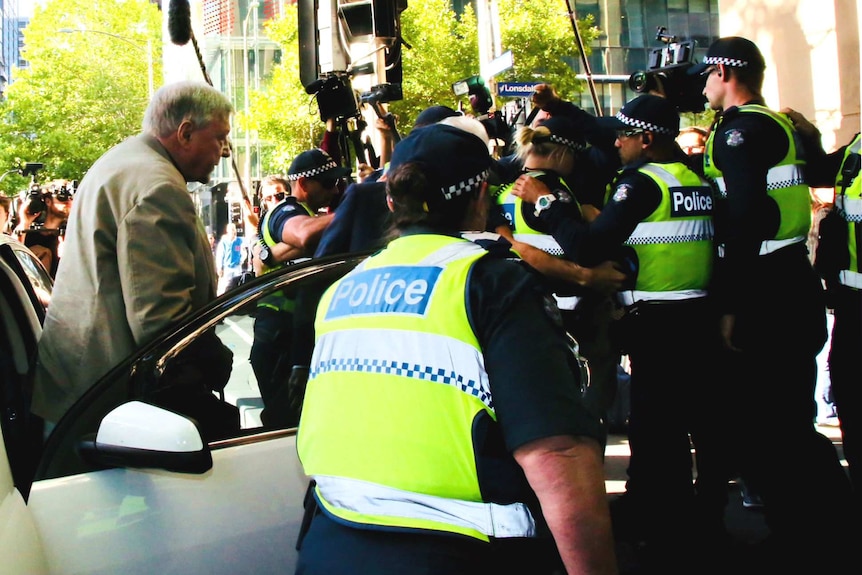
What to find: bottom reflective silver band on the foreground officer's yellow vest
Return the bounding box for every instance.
[314,475,536,538]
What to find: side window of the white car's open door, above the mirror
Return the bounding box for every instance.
[36,256,363,479]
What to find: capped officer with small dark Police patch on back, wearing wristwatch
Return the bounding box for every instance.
[524,95,726,572]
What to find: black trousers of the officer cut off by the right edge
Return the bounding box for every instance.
[829,286,862,515]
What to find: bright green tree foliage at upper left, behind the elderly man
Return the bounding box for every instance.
[0,0,162,195]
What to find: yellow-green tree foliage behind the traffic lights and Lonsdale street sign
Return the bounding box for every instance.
[243,0,598,172]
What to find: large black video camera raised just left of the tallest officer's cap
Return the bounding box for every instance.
[628,26,706,112]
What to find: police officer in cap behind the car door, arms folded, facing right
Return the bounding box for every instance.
[249,148,350,425]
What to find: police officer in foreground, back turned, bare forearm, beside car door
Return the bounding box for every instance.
[297,125,616,575]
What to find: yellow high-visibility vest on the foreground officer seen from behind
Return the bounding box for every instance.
[297,235,535,541]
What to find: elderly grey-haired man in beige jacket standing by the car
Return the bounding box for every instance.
[32,82,233,422]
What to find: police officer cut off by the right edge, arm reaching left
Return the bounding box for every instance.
[782,108,862,516]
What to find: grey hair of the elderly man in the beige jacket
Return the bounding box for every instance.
[141,81,233,138]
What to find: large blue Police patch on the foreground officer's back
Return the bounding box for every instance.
[326,266,442,319]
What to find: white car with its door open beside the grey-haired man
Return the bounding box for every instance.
[0,232,365,575]
